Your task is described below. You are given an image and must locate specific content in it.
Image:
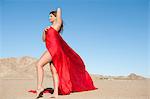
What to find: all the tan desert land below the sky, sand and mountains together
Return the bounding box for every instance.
[0,56,150,99]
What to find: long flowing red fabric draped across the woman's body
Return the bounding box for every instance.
[46,27,97,95]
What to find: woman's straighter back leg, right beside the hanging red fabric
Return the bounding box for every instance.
[50,63,59,98]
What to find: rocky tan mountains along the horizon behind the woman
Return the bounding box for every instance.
[0,56,146,80]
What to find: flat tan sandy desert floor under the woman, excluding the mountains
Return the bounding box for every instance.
[0,78,150,99]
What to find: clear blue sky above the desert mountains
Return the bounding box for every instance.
[0,0,150,77]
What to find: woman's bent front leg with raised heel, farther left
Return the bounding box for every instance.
[36,51,52,97]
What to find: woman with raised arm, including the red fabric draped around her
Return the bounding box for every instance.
[37,8,97,97]
